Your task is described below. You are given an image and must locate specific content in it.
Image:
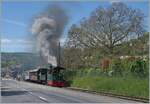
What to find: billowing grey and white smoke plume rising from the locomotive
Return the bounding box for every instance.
[32,5,68,66]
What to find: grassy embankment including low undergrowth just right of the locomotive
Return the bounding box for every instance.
[64,69,149,98]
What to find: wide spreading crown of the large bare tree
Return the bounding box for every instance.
[67,3,144,54]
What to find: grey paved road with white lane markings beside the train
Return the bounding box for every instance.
[1,79,139,103]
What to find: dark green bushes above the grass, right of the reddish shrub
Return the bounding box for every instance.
[108,59,149,78]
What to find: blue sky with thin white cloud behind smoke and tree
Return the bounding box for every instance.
[0,1,148,52]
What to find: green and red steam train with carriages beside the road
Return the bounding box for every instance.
[24,66,65,87]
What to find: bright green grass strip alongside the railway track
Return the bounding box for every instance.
[71,76,149,98]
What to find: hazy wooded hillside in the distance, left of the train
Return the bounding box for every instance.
[1,52,45,77]
